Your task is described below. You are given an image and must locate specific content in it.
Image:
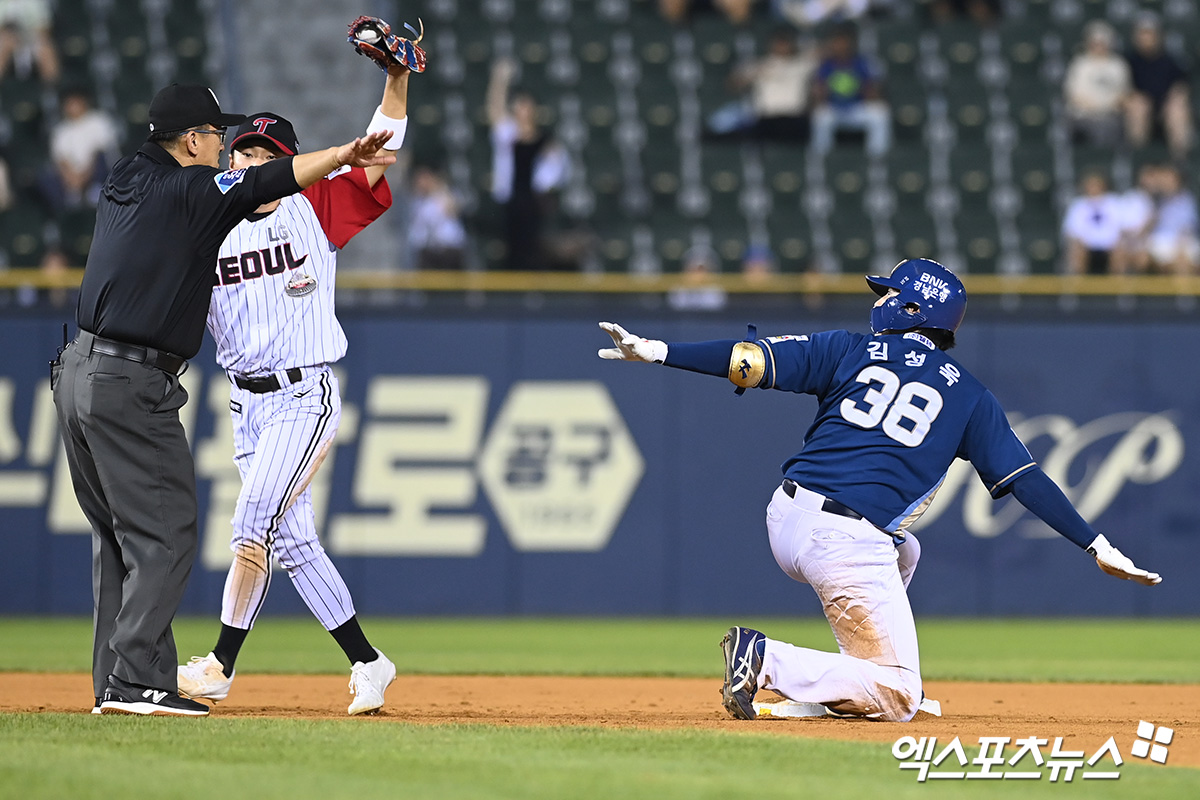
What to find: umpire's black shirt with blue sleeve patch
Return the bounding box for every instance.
[77,142,300,359]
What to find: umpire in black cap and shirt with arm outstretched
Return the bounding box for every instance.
[50,84,395,716]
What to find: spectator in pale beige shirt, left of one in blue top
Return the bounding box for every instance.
[708,25,817,142]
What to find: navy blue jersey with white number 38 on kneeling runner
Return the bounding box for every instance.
[756,331,1037,531]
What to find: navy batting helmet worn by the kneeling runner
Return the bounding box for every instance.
[866,258,967,333]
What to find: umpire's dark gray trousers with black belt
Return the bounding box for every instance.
[50,339,198,697]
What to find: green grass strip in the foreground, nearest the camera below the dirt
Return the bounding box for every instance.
[0,714,1200,800]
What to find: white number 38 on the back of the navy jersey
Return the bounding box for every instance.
[839,365,942,447]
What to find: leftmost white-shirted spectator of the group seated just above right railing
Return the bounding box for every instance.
[1062,172,1126,275]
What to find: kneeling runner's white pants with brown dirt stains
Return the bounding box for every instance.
[758,487,922,722]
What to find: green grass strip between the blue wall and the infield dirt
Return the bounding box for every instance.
[0,618,1200,682]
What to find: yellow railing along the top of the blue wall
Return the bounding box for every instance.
[7,269,1200,297]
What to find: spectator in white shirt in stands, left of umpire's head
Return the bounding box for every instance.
[41,89,119,213]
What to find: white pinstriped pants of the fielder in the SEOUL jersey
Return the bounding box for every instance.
[221,367,354,630]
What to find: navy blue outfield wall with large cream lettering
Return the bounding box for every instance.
[0,314,1200,615]
